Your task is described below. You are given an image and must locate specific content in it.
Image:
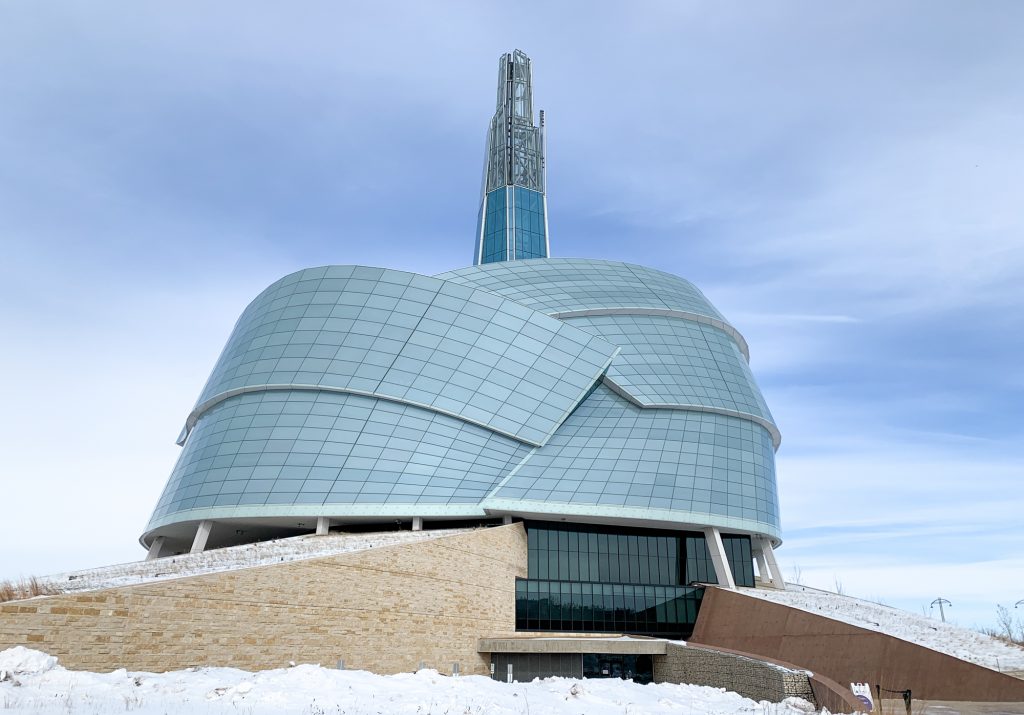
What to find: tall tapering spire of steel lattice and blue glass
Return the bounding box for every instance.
[473,50,550,265]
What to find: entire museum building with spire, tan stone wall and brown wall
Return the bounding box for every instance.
[0,50,1024,700]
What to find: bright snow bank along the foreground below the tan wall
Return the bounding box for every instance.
[0,646,827,715]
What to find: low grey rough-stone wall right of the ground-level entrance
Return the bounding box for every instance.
[654,643,814,703]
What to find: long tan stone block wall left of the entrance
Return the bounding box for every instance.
[0,523,526,675]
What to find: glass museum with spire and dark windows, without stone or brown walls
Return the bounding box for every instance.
[140,50,780,651]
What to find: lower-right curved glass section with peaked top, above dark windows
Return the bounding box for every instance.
[479,384,778,531]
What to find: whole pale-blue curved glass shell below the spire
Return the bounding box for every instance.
[146,260,779,553]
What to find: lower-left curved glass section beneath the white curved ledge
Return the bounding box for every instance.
[153,390,528,521]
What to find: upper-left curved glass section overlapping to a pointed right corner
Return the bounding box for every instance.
[186,265,616,445]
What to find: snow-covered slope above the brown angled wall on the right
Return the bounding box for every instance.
[739,584,1024,672]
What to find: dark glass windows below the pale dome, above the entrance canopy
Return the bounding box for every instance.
[516,522,754,638]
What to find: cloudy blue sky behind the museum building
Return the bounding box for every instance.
[0,1,1024,625]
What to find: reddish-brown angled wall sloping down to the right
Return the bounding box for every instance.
[690,588,1024,702]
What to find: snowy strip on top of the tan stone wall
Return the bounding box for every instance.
[40,529,469,593]
